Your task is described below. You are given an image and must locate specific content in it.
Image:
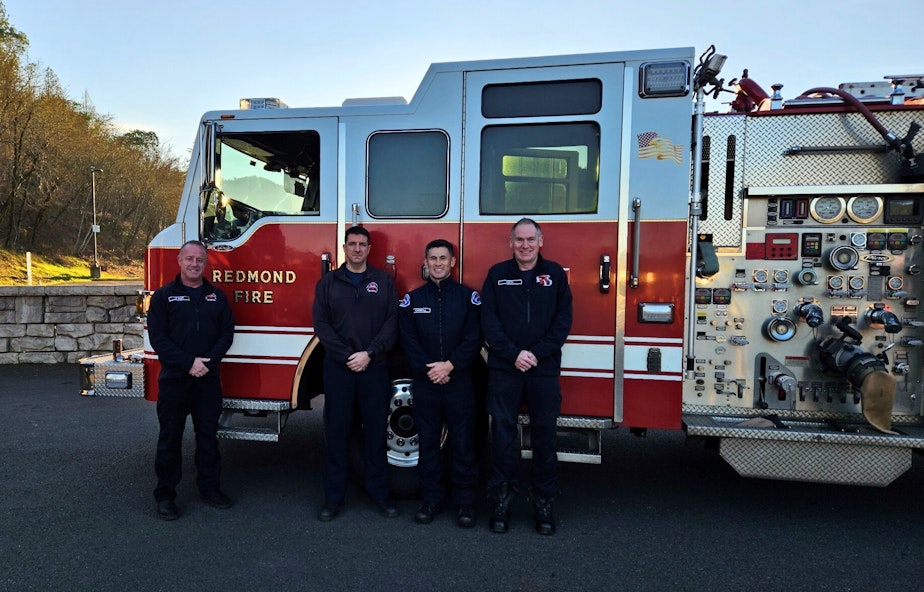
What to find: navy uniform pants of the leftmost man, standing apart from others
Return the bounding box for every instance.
[154,376,221,501]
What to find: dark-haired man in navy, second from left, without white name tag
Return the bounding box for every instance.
[313,226,398,522]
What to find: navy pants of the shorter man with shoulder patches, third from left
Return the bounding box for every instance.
[414,376,478,507]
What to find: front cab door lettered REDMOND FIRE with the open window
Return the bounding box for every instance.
[202,115,341,400]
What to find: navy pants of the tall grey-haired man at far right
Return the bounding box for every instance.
[488,369,561,498]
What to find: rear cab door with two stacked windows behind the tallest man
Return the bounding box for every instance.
[462,63,624,417]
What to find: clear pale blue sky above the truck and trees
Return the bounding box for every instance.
[0,0,924,158]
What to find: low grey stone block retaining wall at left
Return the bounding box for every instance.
[0,284,144,364]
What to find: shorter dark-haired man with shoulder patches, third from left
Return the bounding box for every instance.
[398,239,481,528]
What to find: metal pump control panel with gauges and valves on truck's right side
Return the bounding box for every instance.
[684,191,924,415]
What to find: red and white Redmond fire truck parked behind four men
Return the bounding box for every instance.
[83,48,924,486]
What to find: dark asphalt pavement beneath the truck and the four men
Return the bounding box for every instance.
[0,364,924,592]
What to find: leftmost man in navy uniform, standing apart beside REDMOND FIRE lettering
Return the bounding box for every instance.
[148,241,234,520]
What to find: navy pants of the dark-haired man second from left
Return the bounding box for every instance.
[324,357,391,504]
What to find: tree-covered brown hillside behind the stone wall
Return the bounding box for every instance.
[0,2,185,270]
